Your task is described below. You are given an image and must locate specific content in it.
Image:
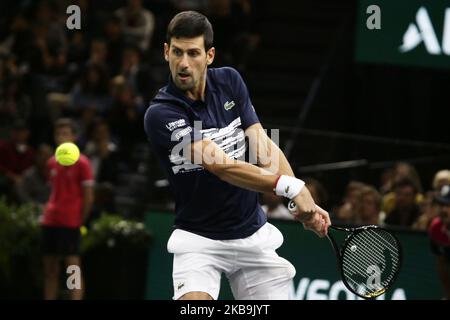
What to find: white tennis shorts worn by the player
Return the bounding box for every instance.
[167,223,295,300]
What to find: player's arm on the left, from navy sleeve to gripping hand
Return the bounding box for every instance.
[144,105,330,236]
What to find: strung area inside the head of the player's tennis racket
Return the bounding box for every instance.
[342,229,400,296]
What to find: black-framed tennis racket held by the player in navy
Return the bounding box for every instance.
[288,201,402,299]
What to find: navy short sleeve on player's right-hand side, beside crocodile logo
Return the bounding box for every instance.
[228,68,259,130]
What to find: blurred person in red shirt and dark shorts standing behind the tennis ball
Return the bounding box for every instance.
[42,119,94,300]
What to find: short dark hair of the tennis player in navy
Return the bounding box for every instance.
[166,11,214,51]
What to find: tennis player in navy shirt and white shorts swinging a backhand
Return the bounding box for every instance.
[144,11,330,300]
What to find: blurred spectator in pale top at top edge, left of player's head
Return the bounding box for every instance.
[115,0,155,52]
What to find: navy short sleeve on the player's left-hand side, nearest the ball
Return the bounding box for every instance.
[144,104,202,151]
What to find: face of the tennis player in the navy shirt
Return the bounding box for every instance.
[164,36,215,91]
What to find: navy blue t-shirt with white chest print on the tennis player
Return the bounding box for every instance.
[144,67,266,240]
